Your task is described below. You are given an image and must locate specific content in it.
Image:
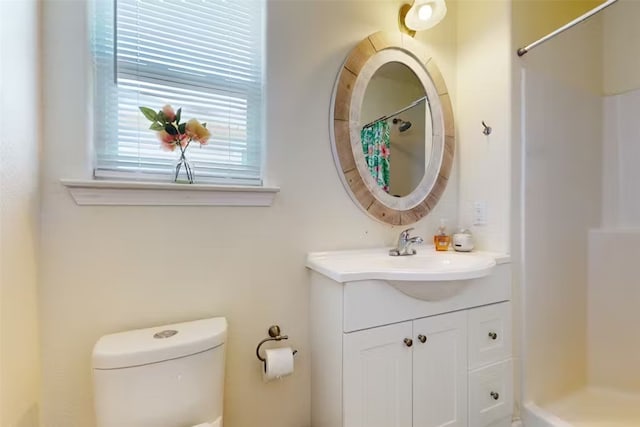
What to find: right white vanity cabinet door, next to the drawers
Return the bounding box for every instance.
[413,311,467,427]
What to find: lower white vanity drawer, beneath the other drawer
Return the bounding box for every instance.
[469,359,513,427]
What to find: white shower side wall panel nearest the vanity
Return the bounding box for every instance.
[521,71,602,402]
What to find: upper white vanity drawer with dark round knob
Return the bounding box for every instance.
[468,302,511,369]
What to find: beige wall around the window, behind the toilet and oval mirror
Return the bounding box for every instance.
[40,0,457,427]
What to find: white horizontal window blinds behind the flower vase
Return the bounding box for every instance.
[92,0,264,185]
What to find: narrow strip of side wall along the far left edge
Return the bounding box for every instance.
[0,0,40,427]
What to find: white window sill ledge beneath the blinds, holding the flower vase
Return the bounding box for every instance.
[60,179,280,206]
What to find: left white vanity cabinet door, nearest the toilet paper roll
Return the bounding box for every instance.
[342,322,415,427]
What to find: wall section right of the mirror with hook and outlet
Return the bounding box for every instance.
[456,0,511,252]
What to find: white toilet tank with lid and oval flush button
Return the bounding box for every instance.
[93,317,227,427]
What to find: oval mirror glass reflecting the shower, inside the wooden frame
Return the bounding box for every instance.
[360,62,432,197]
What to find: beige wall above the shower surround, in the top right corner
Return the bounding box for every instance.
[603,0,640,95]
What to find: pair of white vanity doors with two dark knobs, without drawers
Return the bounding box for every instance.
[343,313,467,427]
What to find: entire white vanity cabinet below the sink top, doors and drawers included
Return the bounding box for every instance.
[310,252,513,427]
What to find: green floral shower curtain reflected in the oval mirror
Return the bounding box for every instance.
[360,120,391,193]
